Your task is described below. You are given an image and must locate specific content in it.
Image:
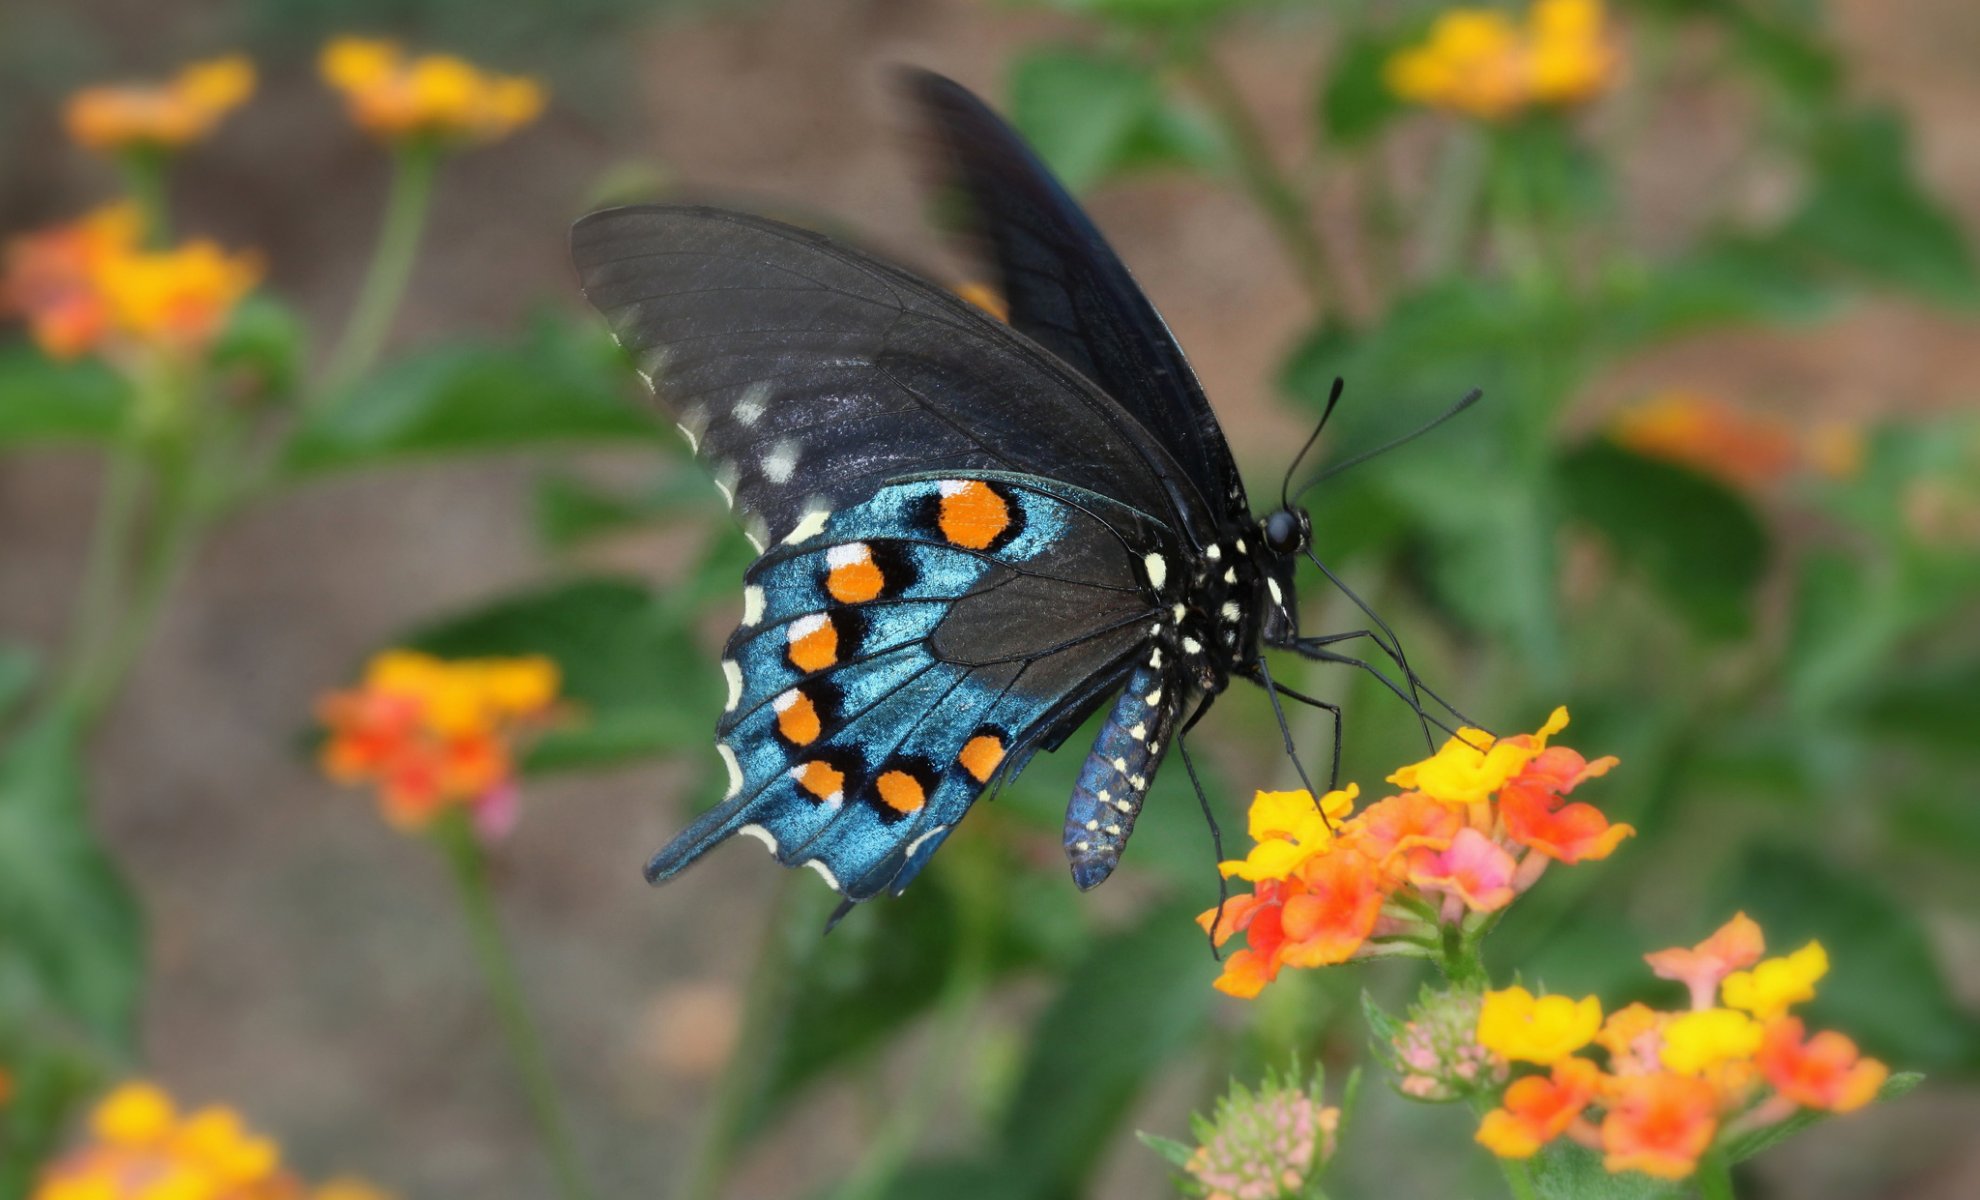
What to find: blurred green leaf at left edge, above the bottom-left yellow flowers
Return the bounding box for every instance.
[0,719,143,1051]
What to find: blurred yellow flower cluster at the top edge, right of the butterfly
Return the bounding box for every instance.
[1386,0,1618,121]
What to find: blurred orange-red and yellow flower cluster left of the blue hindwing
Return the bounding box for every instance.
[319,650,560,840]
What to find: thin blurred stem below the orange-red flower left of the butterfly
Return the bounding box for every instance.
[436,810,592,1200]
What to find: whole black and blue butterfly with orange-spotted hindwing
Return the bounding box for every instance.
[570,71,1457,913]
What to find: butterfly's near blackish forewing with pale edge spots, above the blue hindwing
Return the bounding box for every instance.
[570,206,1186,549]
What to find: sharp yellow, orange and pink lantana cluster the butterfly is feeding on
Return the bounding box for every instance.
[1198,709,1635,996]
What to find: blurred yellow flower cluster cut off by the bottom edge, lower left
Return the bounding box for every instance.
[32,1083,388,1200]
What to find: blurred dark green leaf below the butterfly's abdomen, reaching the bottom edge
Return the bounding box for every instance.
[1002,905,1216,1194]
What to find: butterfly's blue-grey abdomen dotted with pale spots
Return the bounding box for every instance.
[1065,665,1182,891]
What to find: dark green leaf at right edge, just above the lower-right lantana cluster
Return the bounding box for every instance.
[1721,846,1980,1069]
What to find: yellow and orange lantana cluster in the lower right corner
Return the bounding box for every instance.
[1477,913,1889,1180]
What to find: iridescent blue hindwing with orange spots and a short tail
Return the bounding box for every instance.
[647,475,1174,901]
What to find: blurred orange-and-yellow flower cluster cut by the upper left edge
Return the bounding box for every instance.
[0,204,261,358]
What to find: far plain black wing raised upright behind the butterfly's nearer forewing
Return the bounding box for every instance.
[905,71,1249,519]
